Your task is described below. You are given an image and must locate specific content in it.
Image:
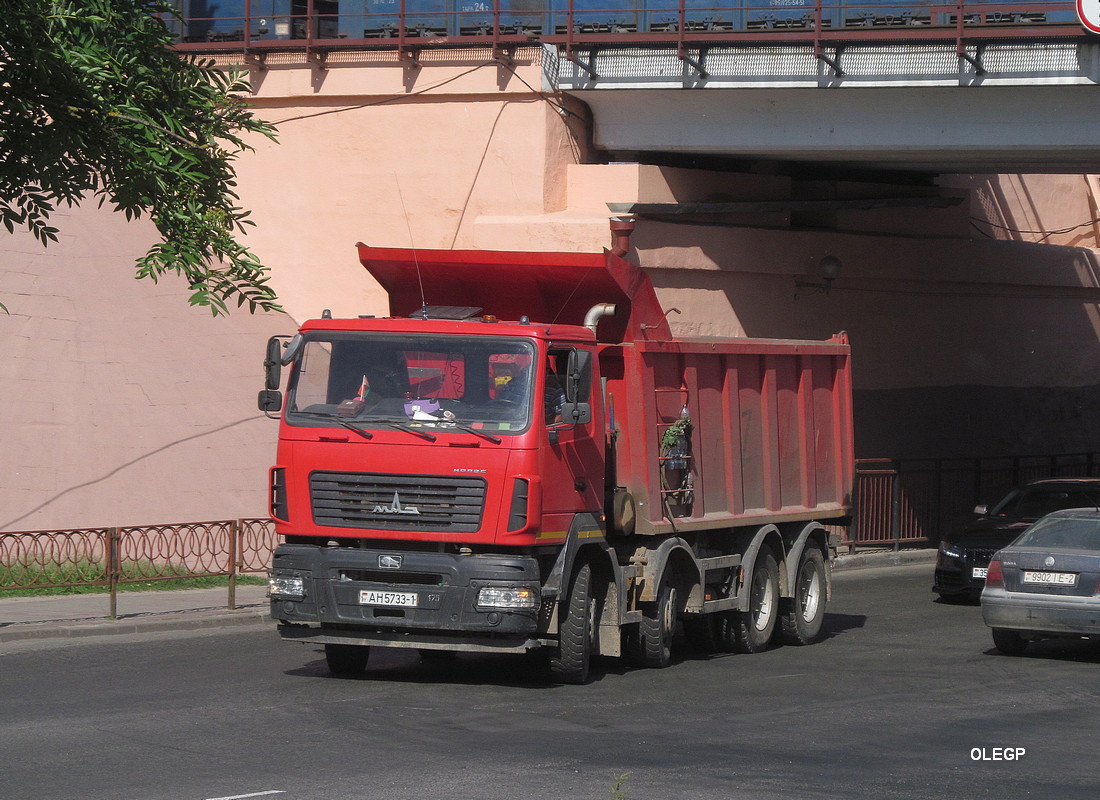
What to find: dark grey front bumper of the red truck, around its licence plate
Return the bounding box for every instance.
[271,545,546,651]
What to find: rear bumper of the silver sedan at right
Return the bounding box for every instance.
[981,589,1100,637]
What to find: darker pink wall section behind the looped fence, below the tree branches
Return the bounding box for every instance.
[0,204,293,530]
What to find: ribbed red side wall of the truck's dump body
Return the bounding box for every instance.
[602,336,854,534]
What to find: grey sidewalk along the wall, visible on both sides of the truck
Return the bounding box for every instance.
[0,548,936,646]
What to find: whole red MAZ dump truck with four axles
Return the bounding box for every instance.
[260,228,854,683]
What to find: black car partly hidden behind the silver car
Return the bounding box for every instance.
[932,478,1100,600]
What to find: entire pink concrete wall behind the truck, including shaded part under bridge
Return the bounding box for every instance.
[0,50,1100,530]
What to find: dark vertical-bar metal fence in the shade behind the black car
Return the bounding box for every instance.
[844,452,1100,549]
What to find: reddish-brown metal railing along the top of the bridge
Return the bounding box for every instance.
[165,0,1085,54]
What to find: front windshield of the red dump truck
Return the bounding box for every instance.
[286,331,536,438]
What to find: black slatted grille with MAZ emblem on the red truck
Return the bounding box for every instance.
[309,472,485,533]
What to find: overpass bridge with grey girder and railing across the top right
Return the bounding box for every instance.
[173,0,1100,173]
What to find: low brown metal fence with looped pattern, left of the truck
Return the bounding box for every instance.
[0,518,278,618]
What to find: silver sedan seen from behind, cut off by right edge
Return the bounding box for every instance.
[981,508,1100,656]
